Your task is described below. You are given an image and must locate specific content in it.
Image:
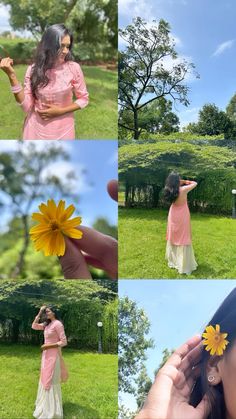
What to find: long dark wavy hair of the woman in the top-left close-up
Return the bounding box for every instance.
[30,24,73,98]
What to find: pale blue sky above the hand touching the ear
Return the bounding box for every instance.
[119,280,236,408]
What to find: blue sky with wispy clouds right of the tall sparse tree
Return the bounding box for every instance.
[119,0,236,126]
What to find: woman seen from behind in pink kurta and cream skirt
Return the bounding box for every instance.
[164,173,197,274]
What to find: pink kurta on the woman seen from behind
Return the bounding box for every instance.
[166,200,192,246]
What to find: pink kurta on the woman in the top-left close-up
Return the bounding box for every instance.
[20,61,88,140]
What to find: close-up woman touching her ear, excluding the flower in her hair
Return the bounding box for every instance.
[136,288,236,419]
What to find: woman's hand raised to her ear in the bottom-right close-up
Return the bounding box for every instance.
[136,336,210,419]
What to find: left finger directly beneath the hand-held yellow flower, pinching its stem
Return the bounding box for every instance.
[59,237,91,279]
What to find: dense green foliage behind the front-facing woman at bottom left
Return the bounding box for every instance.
[0,279,118,352]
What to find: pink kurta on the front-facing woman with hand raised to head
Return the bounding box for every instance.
[32,320,68,390]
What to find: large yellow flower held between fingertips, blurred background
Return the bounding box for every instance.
[30,199,83,256]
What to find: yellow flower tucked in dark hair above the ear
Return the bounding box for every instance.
[202,324,229,356]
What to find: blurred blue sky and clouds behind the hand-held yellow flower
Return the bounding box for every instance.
[0,140,117,233]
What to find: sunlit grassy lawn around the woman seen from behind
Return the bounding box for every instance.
[119,208,236,279]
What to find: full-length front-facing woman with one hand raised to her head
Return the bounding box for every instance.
[32,306,68,419]
